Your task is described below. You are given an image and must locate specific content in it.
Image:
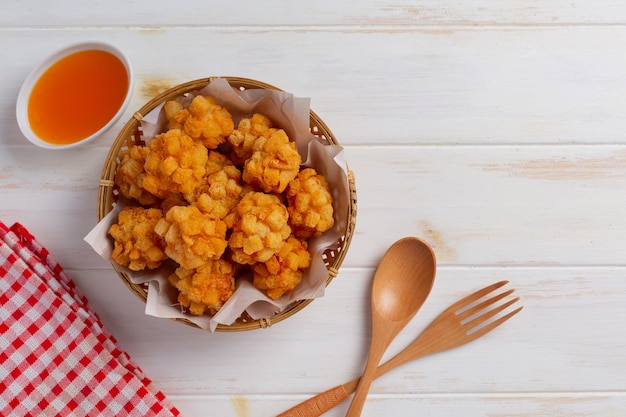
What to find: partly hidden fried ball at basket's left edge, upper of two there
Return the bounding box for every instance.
[115,146,158,206]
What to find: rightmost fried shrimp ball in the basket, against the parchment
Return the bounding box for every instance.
[286,168,335,239]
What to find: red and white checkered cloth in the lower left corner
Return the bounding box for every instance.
[0,222,180,417]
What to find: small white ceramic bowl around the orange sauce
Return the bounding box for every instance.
[16,42,133,149]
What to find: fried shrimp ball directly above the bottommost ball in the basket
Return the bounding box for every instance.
[154,206,227,269]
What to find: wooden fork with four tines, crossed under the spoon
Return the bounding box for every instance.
[278,281,523,417]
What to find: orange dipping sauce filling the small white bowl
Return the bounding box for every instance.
[28,49,128,145]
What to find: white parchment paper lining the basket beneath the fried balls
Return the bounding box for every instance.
[85,78,350,332]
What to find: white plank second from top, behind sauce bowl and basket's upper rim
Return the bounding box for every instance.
[0,26,626,147]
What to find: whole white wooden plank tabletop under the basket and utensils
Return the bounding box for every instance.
[0,0,626,417]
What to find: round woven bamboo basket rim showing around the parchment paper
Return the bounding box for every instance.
[98,77,357,332]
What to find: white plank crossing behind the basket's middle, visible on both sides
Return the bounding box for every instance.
[0,145,626,268]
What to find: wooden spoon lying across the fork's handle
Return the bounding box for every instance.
[346,237,436,417]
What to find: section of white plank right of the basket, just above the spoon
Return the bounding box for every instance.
[346,145,626,266]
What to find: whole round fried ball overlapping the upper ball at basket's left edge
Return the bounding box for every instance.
[143,129,208,198]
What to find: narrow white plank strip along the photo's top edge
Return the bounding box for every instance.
[0,0,626,27]
